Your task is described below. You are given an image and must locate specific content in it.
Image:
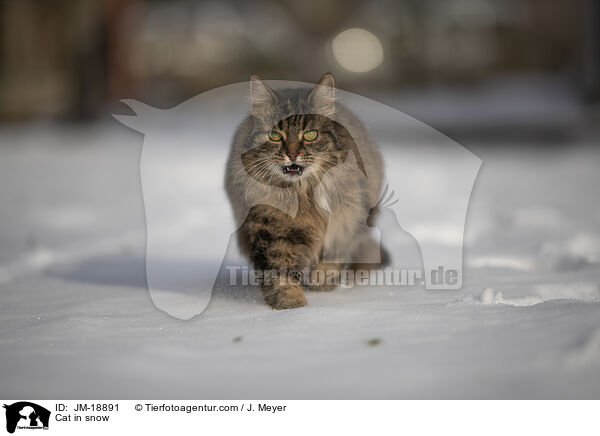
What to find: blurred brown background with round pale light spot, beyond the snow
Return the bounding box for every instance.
[0,0,600,142]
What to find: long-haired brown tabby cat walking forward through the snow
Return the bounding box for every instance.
[226,74,383,309]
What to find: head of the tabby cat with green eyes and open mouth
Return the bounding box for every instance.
[242,74,355,186]
